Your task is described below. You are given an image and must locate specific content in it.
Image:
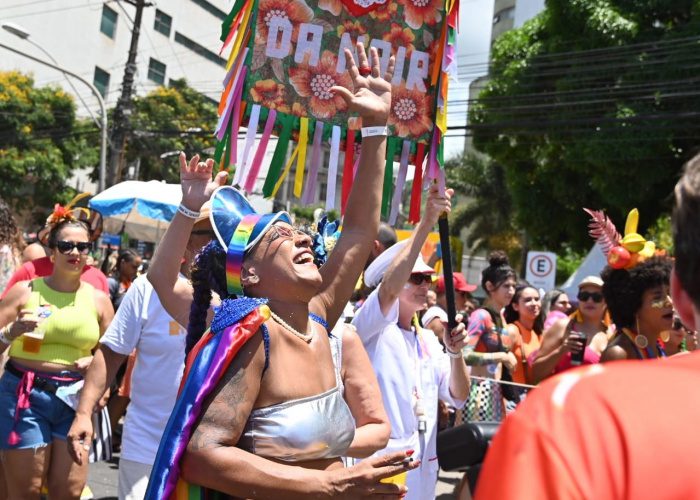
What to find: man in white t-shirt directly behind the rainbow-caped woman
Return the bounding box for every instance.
[68,207,214,500]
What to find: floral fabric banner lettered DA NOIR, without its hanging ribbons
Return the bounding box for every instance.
[250,0,445,143]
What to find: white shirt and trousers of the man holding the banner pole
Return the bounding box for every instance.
[352,285,464,500]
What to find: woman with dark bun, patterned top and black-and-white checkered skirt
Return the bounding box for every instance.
[465,251,518,421]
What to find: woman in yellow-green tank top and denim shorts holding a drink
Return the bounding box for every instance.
[0,213,114,499]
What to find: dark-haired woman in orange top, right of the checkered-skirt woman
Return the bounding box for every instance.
[503,282,544,384]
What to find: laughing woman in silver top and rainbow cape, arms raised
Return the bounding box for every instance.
[146,44,417,499]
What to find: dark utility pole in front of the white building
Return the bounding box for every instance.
[106,0,153,187]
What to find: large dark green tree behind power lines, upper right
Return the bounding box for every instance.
[470,0,700,250]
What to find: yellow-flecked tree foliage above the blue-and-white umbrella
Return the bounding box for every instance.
[126,80,217,183]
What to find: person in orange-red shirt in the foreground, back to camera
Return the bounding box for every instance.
[476,155,700,499]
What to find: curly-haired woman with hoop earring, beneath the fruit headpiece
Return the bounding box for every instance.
[600,256,673,362]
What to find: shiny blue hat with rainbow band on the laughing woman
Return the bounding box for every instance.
[209,186,292,295]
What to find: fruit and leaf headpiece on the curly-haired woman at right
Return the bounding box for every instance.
[583,208,665,269]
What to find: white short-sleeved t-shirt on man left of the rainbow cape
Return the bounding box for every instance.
[100,276,187,464]
